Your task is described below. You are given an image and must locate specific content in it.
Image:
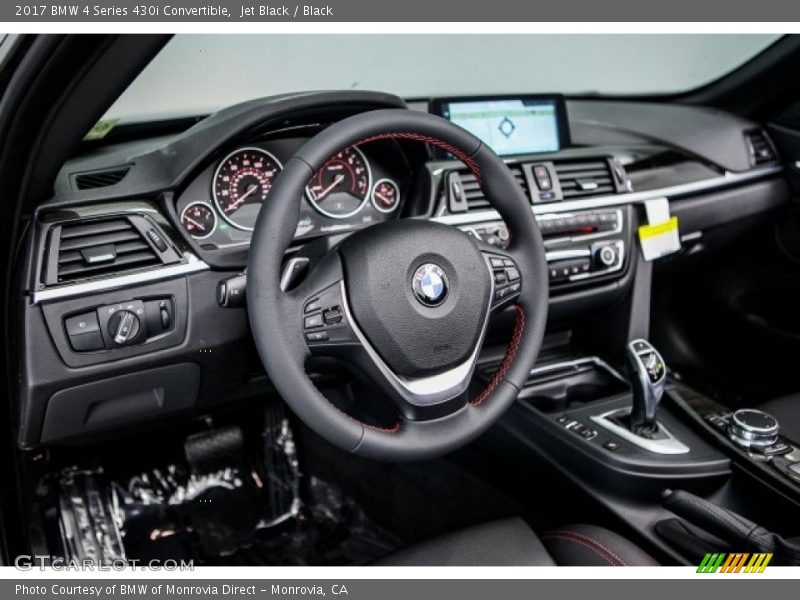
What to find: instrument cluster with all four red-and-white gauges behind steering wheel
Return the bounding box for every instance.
[176,138,410,250]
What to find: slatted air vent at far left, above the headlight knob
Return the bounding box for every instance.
[44,215,181,285]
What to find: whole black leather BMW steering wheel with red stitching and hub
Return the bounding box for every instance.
[247,109,548,461]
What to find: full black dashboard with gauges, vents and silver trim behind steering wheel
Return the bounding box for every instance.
[13,91,790,448]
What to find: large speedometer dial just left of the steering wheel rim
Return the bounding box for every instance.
[212,148,283,231]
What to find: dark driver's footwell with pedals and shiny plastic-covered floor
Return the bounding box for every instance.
[58,415,400,565]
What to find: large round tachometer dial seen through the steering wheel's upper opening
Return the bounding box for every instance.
[306,147,372,219]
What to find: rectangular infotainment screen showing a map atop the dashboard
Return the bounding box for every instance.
[431,96,569,156]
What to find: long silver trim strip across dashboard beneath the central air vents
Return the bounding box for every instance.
[430,166,783,225]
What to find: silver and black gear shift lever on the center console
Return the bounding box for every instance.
[626,340,667,434]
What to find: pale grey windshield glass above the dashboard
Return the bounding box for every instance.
[104,34,779,122]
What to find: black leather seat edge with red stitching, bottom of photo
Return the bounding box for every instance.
[376,518,658,567]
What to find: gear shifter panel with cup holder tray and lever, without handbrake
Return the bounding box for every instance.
[480,340,730,488]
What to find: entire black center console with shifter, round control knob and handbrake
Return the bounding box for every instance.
[479,334,800,565]
